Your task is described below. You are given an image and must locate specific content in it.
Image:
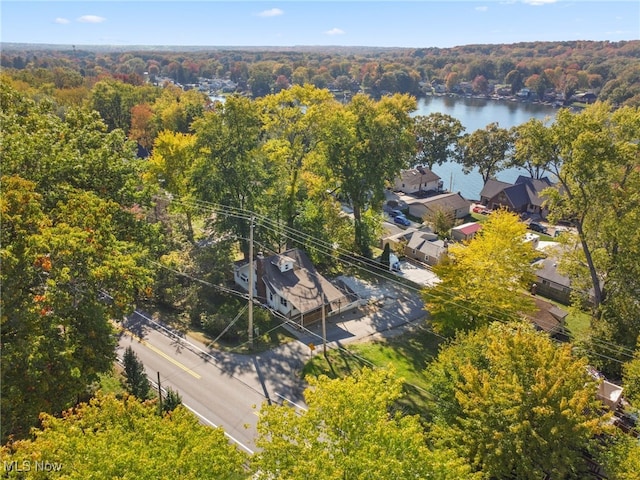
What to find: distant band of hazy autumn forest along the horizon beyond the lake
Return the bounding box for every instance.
[0,41,640,105]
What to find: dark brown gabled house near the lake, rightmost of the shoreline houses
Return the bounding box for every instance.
[480,175,554,218]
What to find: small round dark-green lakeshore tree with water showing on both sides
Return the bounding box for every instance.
[457,122,513,183]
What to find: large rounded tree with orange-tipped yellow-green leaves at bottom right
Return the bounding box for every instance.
[427,322,607,479]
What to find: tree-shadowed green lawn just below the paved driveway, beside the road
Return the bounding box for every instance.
[303,325,443,414]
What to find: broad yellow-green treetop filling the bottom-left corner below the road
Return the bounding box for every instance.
[2,394,247,480]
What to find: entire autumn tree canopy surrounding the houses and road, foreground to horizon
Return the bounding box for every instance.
[0,42,640,479]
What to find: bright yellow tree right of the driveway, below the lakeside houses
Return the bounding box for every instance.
[422,210,536,334]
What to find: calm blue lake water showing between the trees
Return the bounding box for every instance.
[414,96,557,200]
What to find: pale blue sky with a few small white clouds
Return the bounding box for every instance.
[0,0,640,48]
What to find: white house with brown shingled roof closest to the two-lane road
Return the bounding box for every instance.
[233,248,358,326]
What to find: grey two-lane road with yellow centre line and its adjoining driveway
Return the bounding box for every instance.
[118,276,424,452]
